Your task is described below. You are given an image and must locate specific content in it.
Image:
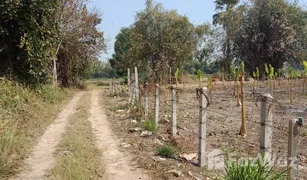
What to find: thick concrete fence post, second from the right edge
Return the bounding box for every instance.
[260,94,273,163]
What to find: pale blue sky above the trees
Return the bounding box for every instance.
[89,0,215,61]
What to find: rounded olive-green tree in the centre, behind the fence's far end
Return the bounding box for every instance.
[131,0,204,81]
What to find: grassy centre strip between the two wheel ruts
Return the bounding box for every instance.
[48,93,103,180]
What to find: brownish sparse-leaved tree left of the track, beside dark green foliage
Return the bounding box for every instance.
[54,0,106,87]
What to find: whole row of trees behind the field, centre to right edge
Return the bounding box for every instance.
[109,0,307,81]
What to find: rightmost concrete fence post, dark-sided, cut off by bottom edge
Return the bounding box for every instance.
[287,119,299,180]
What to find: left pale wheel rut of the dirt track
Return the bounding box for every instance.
[14,92,83,180]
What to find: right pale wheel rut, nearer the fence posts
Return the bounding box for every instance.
[90,90,149,180]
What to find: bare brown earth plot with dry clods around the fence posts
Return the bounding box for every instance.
[104,81,307,180]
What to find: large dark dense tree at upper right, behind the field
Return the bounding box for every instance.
[235,0,296,72]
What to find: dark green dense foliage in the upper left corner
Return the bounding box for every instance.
[0,0,58,85]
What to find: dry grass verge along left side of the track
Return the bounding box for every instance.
[0,78,71,179]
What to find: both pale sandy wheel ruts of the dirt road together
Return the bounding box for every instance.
[14,90,148,180]
